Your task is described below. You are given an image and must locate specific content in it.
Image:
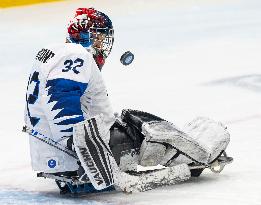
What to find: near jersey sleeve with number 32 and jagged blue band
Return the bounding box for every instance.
[44,46,92,141]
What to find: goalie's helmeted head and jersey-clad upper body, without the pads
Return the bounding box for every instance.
[25,8,115,184]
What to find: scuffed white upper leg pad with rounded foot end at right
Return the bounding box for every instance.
[142,118,229,165]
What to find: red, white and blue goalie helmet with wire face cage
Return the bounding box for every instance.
[66,8,114,70]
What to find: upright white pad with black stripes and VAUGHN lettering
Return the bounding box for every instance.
[73,116,116,190]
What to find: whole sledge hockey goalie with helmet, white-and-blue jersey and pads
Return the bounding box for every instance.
[24,8,232,192]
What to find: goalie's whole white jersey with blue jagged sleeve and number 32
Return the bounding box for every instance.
[25,43,115,173]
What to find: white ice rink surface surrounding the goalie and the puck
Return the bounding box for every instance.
[0,0,261,205]
